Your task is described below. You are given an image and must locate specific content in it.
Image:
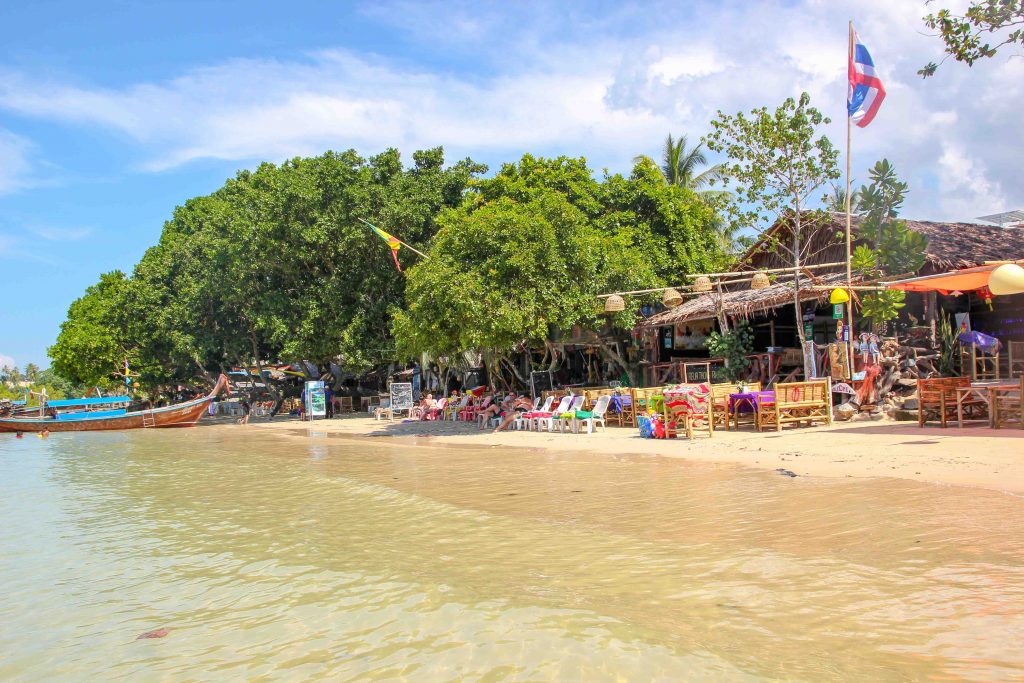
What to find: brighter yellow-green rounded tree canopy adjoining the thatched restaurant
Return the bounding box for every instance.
[395,155,722,382]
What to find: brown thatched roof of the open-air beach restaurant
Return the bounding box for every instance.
[640,213,1024,328]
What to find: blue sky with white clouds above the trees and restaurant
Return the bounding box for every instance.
[0,0,1024,368]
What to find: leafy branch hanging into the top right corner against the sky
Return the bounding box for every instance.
[918,0,1024,78]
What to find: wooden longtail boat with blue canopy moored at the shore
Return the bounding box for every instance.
[0,375,227,432]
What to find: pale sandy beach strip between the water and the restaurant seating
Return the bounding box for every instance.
[246,415,1024,494]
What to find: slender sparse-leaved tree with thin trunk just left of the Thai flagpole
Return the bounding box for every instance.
[707,92,840,343]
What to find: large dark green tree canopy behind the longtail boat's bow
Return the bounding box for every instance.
[50,148,486,393]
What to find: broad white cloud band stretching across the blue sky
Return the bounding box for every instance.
[0,0,1024,219]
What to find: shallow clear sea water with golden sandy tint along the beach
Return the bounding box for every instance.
[0,427,1024,681]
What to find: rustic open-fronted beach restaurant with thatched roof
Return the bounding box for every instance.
[636,213,1024,386]
